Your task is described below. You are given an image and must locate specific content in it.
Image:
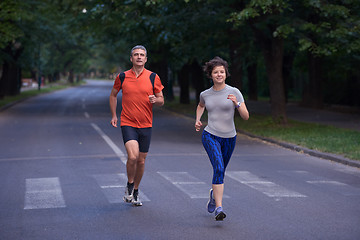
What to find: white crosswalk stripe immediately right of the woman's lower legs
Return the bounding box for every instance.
[226,171,306,198]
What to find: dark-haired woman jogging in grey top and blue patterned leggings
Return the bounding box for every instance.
[195,57,249,221]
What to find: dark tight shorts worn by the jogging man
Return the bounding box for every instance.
[121,126,152,153]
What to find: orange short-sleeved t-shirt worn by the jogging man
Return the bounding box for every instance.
[114,68,164,128]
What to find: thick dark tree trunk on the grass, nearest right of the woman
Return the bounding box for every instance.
[264,38,287,124]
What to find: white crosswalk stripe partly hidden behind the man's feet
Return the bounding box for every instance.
[93,173,150,203]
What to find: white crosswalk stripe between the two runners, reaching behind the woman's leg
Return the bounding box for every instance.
[158,172,229,198]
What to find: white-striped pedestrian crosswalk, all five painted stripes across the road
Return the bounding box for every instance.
[24,170,360,210]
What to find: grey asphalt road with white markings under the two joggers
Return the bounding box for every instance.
[0,81,360,240]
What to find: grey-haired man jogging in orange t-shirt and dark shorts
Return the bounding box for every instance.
[109,45,164,206]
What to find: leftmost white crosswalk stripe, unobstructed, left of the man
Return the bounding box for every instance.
[24,177,66,210]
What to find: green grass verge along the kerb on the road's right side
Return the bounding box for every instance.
[165,101,360,161]
